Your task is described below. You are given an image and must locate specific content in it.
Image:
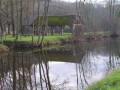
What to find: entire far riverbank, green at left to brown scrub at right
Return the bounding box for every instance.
[3,32,108,48]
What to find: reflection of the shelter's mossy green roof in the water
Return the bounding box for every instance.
[35,51,85,63]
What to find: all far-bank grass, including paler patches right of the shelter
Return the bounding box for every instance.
[3,32,108,43]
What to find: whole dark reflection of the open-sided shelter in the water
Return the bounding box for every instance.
[34,44,86,63]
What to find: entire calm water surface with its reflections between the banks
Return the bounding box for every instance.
[0,40,120,90]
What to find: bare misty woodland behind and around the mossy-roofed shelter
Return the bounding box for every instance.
[0,0,120,39]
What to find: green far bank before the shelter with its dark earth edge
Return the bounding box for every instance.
[3,33,72,48]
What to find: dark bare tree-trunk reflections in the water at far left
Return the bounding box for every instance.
[0,52,51,90]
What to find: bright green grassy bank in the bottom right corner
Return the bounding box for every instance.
[86,70,120,90]
